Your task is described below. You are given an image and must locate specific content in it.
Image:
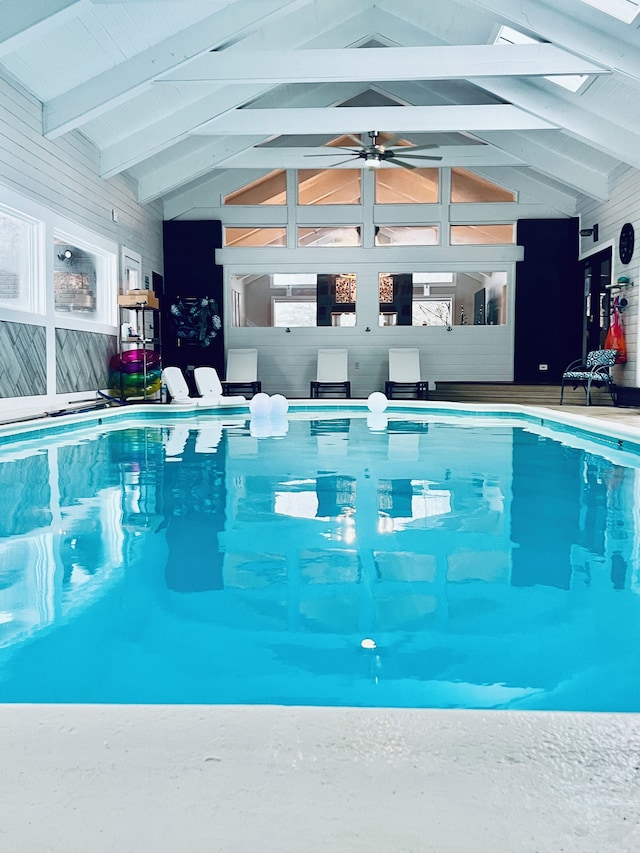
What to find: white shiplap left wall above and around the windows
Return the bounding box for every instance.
[0,66,163,411]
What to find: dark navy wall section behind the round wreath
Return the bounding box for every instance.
[160,219,224,378]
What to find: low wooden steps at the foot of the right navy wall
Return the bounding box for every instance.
[429,382,611,406]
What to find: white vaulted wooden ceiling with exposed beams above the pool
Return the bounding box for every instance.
[0,0,640,215]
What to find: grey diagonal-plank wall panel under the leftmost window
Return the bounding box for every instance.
[0,322,47,397]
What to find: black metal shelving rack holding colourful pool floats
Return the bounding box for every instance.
[118,291,161,402]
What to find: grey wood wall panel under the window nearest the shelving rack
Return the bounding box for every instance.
[56,329,118,394]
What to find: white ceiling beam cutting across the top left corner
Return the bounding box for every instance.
[0,0,84,56]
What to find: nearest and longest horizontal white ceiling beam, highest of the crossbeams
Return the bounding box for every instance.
[158,44,608,83]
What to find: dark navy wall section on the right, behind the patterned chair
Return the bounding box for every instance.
[514,219,584,382]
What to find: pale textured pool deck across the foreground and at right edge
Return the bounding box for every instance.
[0,406,640,853]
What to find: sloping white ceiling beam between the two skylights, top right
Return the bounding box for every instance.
[463,0,640,80]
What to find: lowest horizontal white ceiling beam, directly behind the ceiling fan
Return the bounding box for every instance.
[218,144,523,170]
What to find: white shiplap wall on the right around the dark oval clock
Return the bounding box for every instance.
[578,168,640,387]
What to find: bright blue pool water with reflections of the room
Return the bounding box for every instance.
[0,411,640,712]
